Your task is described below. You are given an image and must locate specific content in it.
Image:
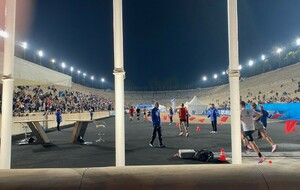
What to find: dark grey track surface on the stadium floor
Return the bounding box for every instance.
[12,117,300,168]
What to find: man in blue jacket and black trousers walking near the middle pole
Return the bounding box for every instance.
[149,102,165,148]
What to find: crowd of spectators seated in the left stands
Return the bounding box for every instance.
[13,86,114,116]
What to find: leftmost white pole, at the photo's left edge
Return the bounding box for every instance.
[0,0,16,169]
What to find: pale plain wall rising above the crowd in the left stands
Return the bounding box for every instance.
[0,52,72,87]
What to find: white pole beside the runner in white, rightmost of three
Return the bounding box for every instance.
[227,0,242,164]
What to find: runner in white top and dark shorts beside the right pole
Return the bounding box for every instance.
[240,101,266,163]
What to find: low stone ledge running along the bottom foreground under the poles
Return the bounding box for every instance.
[0,164,300,190]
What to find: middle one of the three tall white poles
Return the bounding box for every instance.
[113,0,125,166]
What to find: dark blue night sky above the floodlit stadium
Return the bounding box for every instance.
[11,0,300,90]
